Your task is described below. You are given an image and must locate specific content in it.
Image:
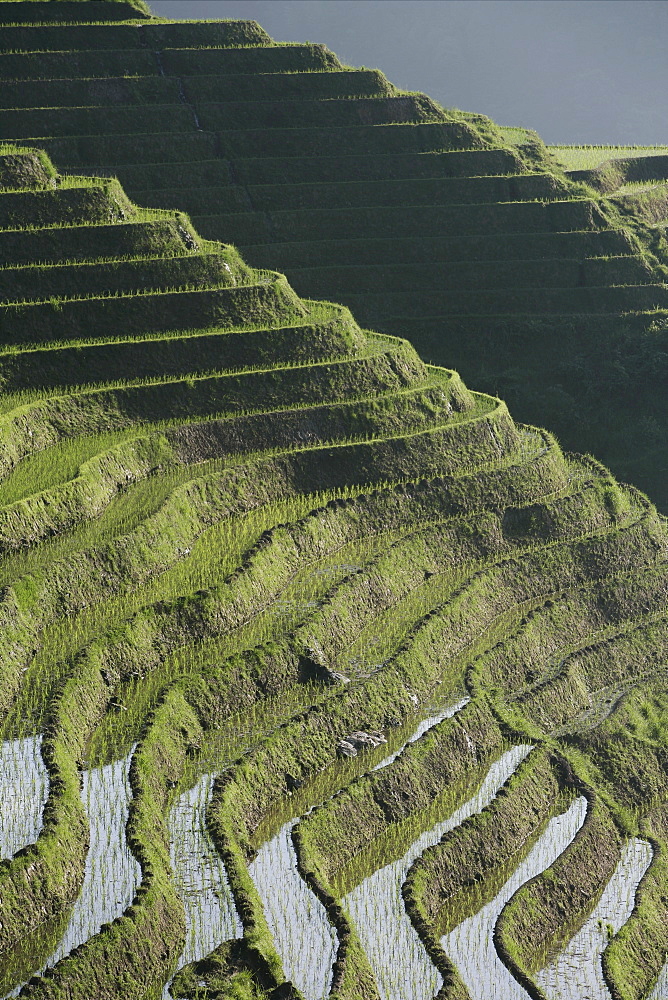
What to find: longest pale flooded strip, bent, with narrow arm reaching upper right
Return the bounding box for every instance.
[344,746,531,1000]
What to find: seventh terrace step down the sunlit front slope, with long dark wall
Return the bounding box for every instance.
[0,351,448,458]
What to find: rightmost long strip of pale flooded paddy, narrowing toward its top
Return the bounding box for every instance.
[536,837,652,1000]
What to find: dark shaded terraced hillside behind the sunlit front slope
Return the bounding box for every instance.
[0,0,668,509]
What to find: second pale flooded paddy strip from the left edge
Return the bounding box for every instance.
[3,754,141,996]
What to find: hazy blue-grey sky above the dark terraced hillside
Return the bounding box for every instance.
[149,0,668,145]
